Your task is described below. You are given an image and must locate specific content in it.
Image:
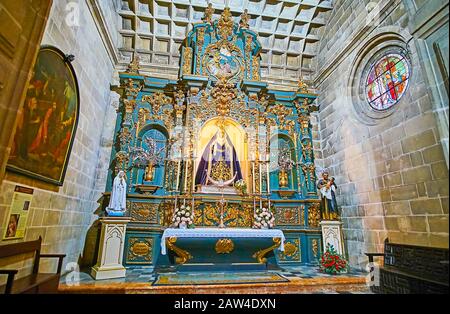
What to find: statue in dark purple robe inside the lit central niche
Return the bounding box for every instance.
[195,125,242,185]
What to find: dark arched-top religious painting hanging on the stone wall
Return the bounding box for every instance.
[7,46,80,185]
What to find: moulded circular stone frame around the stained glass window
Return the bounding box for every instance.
[348,26,414,126]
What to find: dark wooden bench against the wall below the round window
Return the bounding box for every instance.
[366,239,449,294]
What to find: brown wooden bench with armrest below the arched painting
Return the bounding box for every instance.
[0,237,66,294]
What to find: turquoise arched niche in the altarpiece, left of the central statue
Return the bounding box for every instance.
[133,124,169,187]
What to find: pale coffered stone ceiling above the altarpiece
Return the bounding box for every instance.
[118,0,332,81]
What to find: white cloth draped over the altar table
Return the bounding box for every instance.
[161,228,286,255]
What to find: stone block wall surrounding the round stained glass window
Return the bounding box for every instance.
[314,0,449,268]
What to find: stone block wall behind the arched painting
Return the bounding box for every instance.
[0,0,115,280]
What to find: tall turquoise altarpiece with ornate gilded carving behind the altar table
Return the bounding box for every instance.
[102,9,321,266]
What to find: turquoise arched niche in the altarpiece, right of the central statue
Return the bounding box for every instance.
[270,133,298,190]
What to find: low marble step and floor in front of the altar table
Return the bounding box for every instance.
[60,266,370,294]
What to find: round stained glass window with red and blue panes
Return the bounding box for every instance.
[366,53,410,110]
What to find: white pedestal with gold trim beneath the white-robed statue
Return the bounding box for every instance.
[91,217,130,280]
